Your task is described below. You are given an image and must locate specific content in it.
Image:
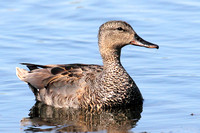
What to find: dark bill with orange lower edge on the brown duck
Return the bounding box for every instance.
[130,34,159,49]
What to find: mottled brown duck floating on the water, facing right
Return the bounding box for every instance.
[16,20,159,110]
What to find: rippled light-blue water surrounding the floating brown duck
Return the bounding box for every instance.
[0,0,200,133]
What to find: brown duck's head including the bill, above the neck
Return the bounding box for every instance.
[99,21,159,53]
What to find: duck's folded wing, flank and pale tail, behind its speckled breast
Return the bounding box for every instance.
[17,63,103,108]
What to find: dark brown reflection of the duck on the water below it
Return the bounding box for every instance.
[21,102,142,133]
